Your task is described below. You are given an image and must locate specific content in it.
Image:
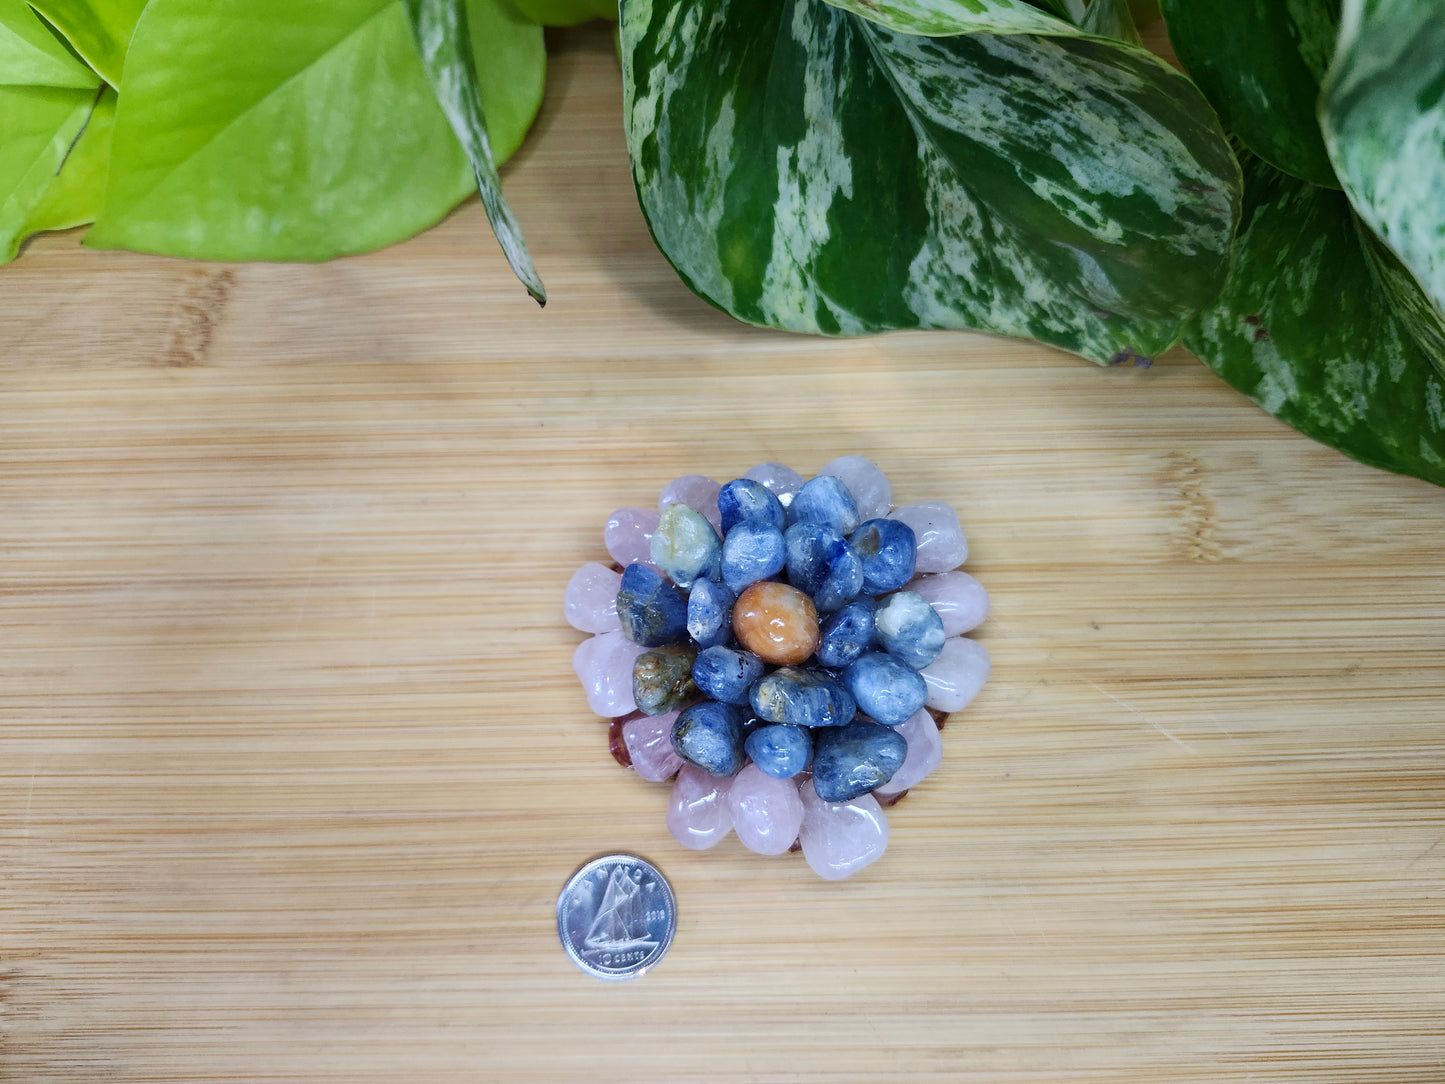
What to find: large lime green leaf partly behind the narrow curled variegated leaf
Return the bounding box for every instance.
[85,0,543,260]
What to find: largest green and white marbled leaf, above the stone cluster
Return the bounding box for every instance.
[621,0,1240,361]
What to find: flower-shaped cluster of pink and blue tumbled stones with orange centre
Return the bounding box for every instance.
[565,455,988,879]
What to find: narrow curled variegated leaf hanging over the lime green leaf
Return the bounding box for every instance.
[403,0,546,305]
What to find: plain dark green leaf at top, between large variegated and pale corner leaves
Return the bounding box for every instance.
[1162,0,1335,188]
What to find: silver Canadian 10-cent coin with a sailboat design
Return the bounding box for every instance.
[556,854,678,980]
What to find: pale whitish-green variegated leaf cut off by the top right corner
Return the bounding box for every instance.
[1321,0,1445,364]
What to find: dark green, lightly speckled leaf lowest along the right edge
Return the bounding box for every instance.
[1183,158,1445,484]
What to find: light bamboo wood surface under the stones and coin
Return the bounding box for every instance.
[0,30,1445,1084]
